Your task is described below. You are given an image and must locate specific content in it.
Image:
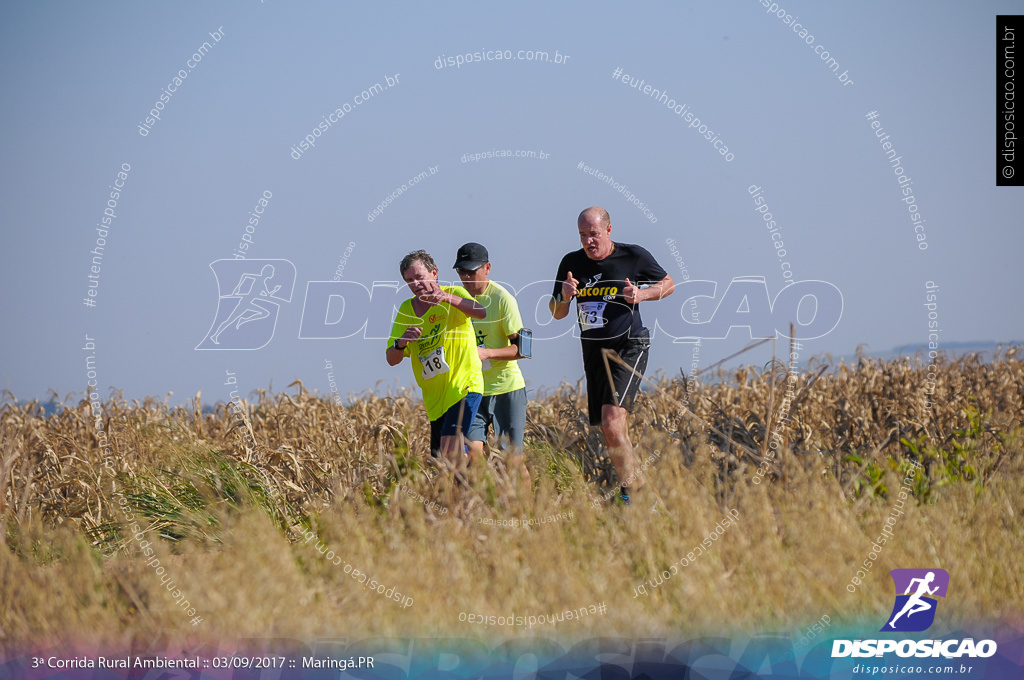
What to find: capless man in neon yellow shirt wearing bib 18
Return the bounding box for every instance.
[385,250,486,463]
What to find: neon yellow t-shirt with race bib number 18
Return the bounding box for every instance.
[387,286,483,420]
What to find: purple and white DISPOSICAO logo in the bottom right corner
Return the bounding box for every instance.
[831,568,996,658]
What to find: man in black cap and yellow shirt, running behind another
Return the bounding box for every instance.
[454,243,530,493]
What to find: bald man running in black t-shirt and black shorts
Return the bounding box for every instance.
[549,206,675,504]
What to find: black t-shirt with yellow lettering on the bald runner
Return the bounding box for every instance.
[552,242,668,340]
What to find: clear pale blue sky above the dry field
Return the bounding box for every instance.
[0,0,1024,401]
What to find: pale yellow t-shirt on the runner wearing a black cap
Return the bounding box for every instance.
[472,281,526,396]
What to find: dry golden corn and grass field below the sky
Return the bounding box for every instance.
[0,347,1024,648]
